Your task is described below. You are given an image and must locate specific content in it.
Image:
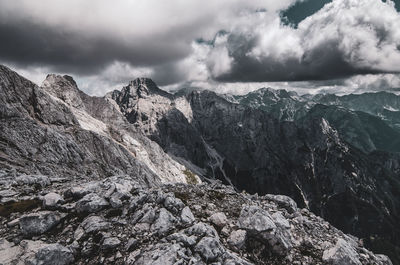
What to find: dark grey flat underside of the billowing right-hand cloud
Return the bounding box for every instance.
[215,35,385,82]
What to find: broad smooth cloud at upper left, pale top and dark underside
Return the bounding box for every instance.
[0,0,295,74]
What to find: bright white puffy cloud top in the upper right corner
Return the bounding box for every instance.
[298,0,400,71]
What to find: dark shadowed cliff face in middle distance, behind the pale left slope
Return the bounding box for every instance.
[106,81,400,262]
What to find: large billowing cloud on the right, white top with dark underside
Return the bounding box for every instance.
[198,0,400,82]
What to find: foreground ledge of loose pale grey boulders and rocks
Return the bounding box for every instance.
[0,172,392,265]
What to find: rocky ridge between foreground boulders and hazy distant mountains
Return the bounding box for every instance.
[0,64,400,264]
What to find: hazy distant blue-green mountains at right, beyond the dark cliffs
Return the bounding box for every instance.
[233,88,400,153]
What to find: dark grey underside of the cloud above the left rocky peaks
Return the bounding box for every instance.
[0,19,190,75]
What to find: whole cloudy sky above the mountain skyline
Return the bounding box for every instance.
[0,0,400,96]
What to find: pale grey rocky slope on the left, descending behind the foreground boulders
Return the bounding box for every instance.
[0,66,200,185]
